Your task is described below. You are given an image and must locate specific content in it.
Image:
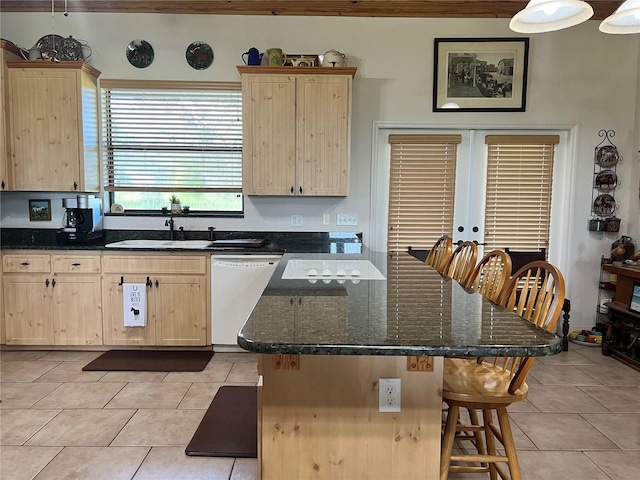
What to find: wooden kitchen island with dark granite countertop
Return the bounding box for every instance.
[238,253,562,480]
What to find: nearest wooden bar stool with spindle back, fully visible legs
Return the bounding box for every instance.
[440,261,565,480]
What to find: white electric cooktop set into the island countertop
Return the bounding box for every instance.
[282,258,385,281]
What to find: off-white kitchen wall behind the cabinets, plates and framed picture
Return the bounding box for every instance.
[0,13,640,328]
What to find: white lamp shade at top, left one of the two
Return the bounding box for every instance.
[509,0,593,33]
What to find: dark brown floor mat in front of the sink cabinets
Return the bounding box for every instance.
[82,350,213,372]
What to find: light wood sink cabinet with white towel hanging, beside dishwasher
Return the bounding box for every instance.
[102,254,210,346]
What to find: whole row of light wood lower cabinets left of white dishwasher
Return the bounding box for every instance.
[0,251,211,346]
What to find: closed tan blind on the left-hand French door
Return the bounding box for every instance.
[387,135,462,252]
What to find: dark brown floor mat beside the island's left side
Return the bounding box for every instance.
[185,385,258,458]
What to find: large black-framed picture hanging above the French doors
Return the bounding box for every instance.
[433,38,529,112]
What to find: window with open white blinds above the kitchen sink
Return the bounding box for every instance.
[101,80,242,212]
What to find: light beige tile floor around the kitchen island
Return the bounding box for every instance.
[0,344,640,480]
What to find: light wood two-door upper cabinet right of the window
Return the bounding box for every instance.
[238,66,356,196]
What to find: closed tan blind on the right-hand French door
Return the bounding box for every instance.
[484,135,560,252]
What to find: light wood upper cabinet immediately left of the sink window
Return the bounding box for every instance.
[7,61,100,192]
